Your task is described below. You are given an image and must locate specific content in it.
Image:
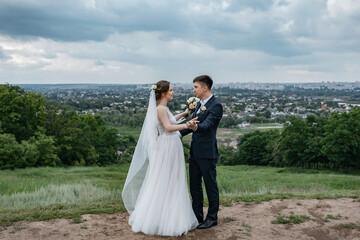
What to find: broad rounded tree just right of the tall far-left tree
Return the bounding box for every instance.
[47,109,119,166]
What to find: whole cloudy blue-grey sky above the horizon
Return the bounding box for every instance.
[0,0,360,84]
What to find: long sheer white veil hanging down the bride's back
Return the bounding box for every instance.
[122,90,158,213]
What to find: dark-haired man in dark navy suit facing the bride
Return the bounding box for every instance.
[180,75,223,229]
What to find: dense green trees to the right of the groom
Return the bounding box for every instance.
[219,108,360,171]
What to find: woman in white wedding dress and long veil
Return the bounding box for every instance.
[122,80,198,236]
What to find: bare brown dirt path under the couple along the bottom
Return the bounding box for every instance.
[0,198,360,240]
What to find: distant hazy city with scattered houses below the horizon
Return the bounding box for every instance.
[19,81,360,119]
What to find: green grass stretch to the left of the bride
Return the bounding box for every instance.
[0,166,128,226]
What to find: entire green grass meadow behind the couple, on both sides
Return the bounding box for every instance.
[0,165,360,225]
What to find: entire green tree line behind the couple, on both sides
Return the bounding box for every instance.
[0,84,360,171]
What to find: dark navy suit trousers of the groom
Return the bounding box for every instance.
[189,156,219,221]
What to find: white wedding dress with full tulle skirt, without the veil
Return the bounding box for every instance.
[129,106,198,236]
